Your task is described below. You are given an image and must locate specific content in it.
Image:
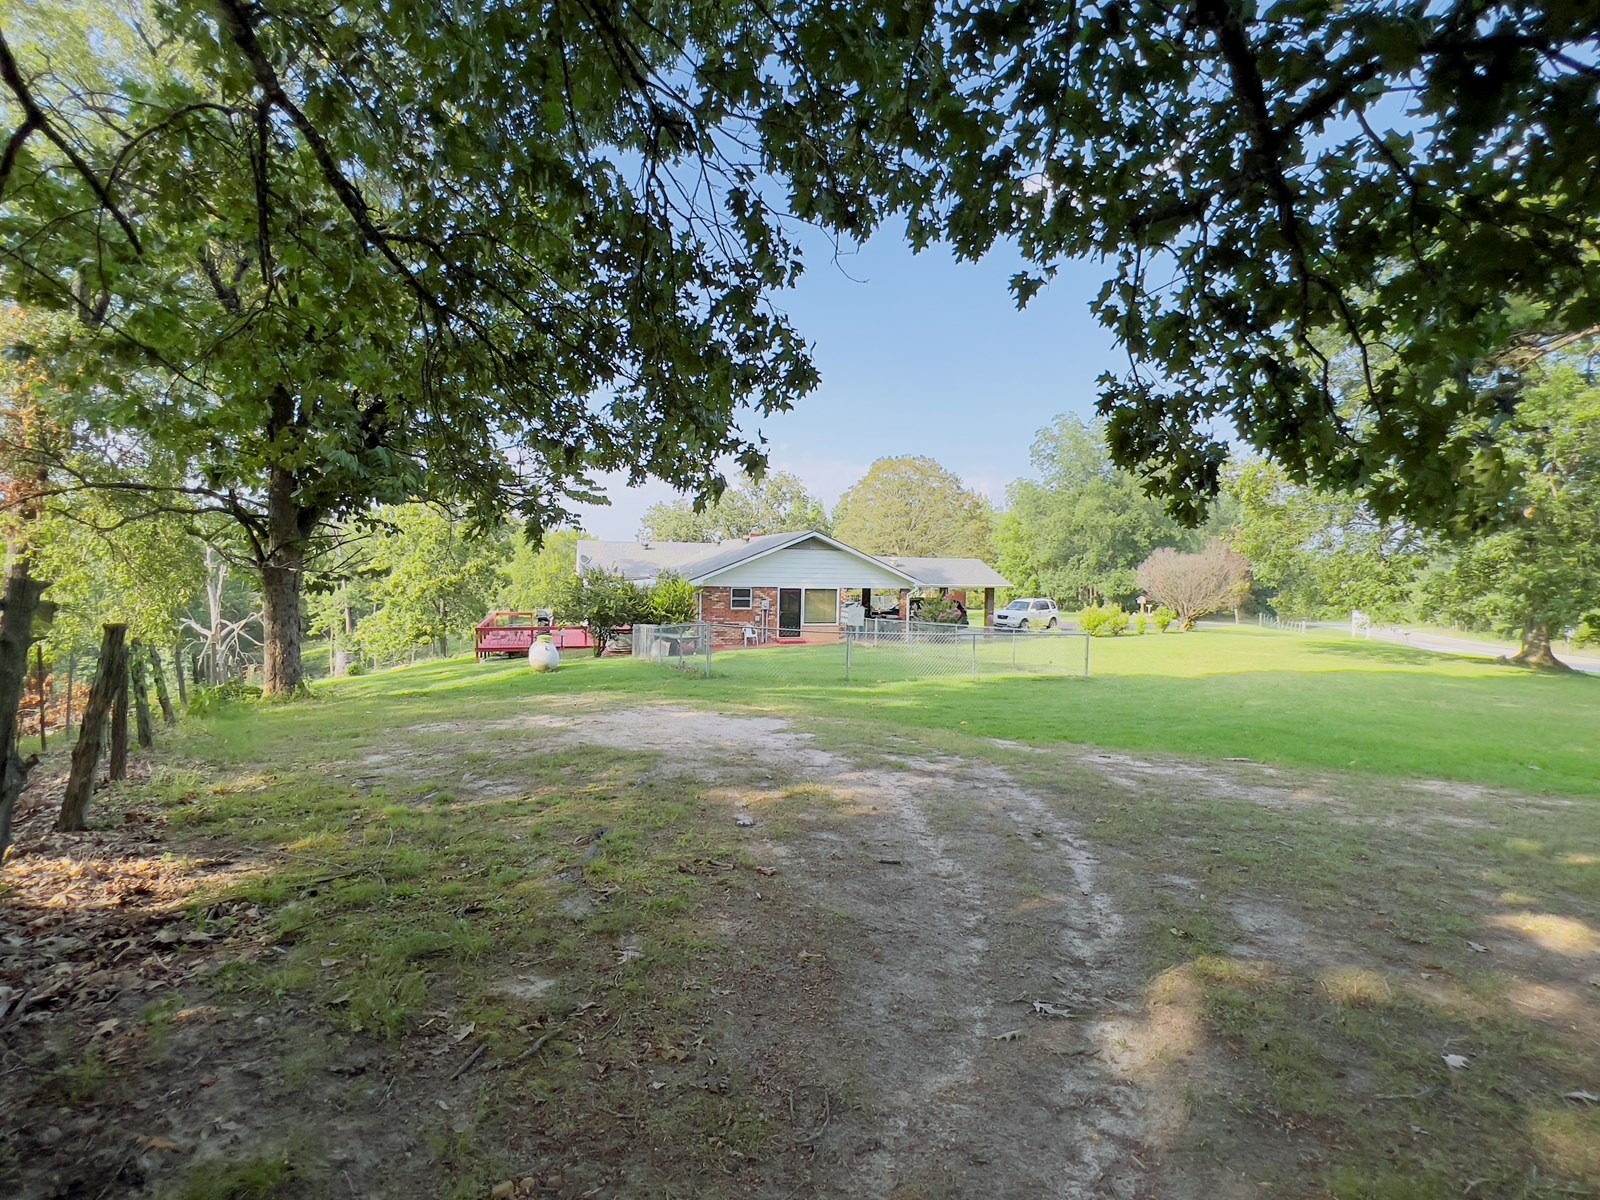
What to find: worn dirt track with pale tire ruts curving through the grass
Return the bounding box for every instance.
[522,707,1173,1200]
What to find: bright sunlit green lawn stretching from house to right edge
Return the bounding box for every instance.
[384,629,1600,809]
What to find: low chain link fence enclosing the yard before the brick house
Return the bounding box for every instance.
[634,621,1090,686]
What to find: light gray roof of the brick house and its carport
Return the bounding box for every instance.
[578,530,1011,587]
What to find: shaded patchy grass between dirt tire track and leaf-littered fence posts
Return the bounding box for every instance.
[121,678,790,1200]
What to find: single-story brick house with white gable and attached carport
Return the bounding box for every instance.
[578,530,1010,642]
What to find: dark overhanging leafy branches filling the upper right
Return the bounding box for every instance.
[790,0,1600,528]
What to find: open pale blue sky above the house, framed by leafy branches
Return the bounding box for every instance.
[569,229,1125,539]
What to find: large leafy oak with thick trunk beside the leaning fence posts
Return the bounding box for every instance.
[0,0,867,694]
